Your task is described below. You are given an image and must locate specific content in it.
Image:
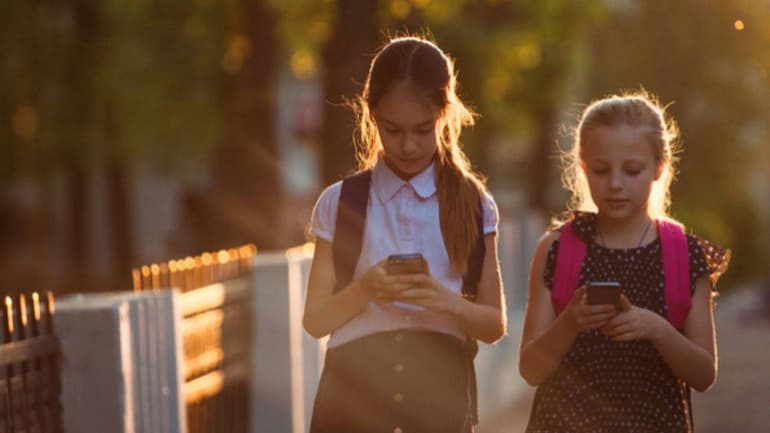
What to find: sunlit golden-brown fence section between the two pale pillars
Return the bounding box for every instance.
[133,245,256,433]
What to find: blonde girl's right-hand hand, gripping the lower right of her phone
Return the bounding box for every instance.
[602,295,668,341]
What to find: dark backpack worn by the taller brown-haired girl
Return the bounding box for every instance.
[332,169,486,425]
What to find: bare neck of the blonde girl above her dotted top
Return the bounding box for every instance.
[595,213,656,249]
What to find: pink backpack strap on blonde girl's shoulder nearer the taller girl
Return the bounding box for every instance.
[551,221,588,316]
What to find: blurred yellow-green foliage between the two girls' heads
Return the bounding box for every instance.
[389,0,603,214]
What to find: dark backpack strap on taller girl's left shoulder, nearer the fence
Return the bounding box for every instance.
[332,170,372,293]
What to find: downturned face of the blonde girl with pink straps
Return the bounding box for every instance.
[581,125,662,220]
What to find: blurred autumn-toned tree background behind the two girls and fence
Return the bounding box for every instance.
[0,0,770,432]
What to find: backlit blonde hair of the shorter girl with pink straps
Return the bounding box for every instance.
[562,90,680,222]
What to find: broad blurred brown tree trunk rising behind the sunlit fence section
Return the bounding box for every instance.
[208,0,282,252]
